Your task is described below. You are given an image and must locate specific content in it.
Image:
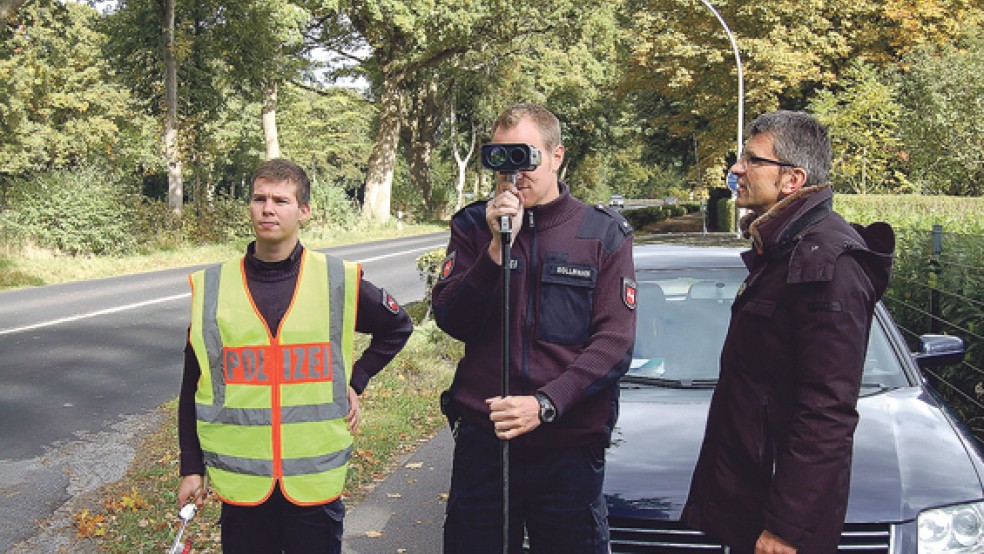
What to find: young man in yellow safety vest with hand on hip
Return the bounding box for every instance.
[178,159,413,554]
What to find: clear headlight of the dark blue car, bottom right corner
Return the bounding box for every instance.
[919,502,984,554]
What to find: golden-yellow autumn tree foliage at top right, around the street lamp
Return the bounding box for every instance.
[625,0,981,185]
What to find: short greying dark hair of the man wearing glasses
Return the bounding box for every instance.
[751,110,833,186]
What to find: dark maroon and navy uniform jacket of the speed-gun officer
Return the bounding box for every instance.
[433,183,635,448]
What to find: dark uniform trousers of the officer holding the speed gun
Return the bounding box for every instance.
[444,422,608,554]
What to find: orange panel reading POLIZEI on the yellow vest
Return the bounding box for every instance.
[222,343,331,385]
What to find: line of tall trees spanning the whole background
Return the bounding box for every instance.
[0,0,984,246]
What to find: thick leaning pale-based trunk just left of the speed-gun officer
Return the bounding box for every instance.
[362,78,402,222]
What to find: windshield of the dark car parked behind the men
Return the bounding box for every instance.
[623,268,908,388]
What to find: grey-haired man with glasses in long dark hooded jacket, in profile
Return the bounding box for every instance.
[683,111,895,554]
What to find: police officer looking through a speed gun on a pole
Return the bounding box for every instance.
[432,104,636,554]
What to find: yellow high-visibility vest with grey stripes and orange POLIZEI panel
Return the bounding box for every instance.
[189,249,361,506]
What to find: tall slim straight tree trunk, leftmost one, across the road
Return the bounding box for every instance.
[162,0,184,217]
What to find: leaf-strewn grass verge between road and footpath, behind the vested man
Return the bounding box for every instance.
[82,321,463,554]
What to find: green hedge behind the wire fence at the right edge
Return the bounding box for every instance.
[834,194,984,440]
